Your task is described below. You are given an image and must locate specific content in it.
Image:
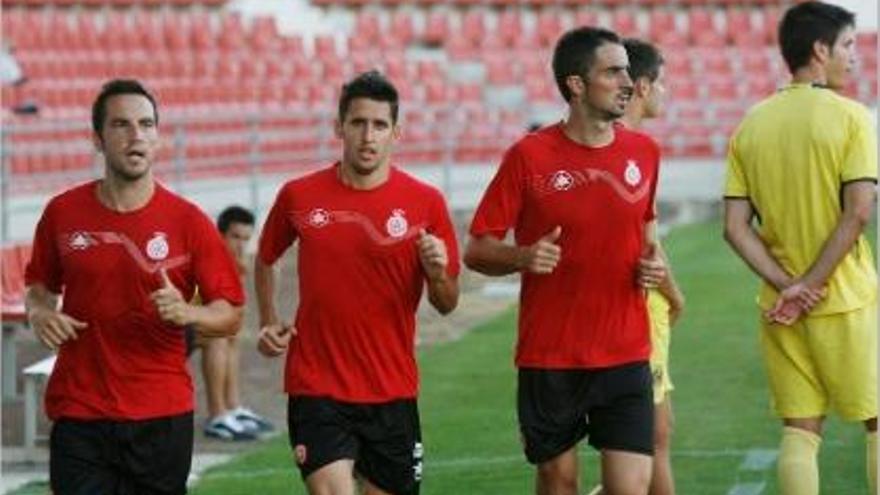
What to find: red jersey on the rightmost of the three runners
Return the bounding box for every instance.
[470,124,660,368]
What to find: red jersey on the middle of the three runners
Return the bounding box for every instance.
[259,164,460,403]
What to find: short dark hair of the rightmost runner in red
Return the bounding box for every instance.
[553,26,620,101]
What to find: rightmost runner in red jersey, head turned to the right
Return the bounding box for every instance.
[465,27,665,495]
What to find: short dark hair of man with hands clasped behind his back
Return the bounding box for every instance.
[779,2,856,73]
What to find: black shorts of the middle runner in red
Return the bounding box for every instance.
[287,396,422,495]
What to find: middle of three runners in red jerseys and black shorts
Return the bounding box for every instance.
[254,71,459,495]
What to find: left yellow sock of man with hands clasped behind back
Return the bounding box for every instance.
[778,426,822,495]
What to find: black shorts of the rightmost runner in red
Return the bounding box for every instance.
[517,362,654,464]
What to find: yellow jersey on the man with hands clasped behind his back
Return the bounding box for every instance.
[725,84,877,315]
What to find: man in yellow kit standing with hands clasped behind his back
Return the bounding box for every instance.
[724,2,877,495]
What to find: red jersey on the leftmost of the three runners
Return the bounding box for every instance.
[25,181,244,420]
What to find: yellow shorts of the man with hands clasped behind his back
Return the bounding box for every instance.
[761,303,877,421]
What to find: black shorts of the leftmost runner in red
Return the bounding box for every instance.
[49,412,193,495]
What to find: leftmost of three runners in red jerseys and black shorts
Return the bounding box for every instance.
[25,80,244,495]
